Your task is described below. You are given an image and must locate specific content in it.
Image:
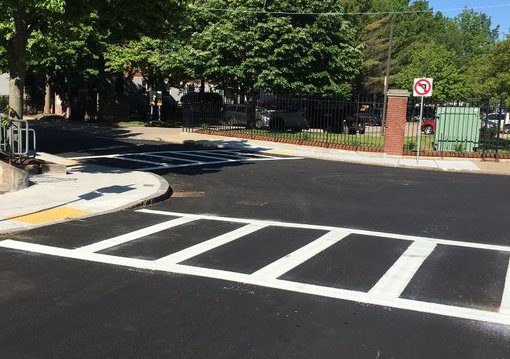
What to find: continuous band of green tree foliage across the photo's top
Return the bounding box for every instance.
[0,0,510,116]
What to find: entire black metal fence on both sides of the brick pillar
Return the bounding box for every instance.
[181,92,510,158]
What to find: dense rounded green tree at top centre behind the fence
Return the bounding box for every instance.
[182,0,362,95]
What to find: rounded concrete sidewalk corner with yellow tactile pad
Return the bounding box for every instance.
[0,165,170,233]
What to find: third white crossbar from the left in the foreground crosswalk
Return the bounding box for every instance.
[252,231,350,279]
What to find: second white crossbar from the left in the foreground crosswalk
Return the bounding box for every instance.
[157,224,266,263]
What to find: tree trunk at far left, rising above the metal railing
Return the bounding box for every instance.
[7,1,29,118]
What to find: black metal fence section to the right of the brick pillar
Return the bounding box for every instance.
[404,101,510,158]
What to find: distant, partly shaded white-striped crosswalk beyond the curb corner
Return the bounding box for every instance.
[70,149,301,171]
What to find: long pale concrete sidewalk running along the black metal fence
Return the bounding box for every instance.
[120,127,510,175]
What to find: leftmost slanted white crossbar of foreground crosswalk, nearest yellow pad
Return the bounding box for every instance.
[75,217,195,252]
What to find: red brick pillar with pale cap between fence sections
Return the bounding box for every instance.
[384,90,410,156]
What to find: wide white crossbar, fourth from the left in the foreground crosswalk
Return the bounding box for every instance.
[369,241,436,299]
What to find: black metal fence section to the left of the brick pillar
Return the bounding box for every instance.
[181,92,384,151]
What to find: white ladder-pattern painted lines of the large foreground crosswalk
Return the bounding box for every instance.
[0,209,510,326]
